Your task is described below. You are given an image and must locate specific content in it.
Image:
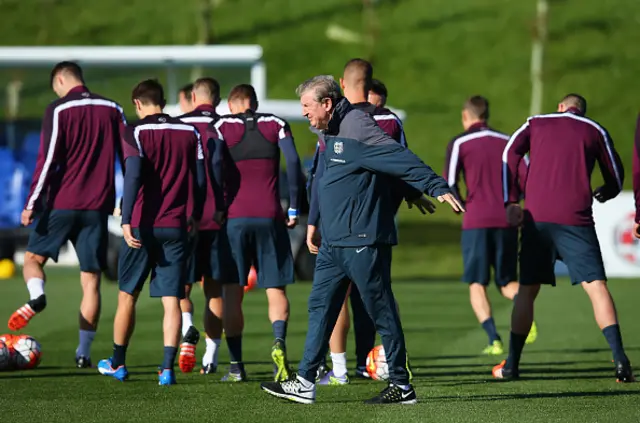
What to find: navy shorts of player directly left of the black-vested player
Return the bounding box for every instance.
[186,229,238,284]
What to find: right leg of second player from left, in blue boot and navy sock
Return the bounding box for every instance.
[149,228,189,385]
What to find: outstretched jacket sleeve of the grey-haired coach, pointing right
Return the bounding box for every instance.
[358,119,451,197]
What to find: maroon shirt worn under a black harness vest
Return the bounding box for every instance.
[214,114,292,219]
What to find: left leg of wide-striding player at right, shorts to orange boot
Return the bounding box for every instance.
[493,221,556,379]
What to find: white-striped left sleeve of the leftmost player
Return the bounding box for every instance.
[25,105,62,210]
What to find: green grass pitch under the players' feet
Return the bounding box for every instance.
[0,269,640,423]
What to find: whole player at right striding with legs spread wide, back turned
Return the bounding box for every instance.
[493,94,634,382]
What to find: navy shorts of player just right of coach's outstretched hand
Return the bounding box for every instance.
[462,228,518,287]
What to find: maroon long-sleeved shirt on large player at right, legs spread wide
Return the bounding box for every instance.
[502,108,624,226]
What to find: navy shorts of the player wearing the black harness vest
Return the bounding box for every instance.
[226,217,294,288]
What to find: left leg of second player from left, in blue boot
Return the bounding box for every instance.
[98,228,154,381]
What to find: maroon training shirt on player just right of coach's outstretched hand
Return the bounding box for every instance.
[443,122,528,229]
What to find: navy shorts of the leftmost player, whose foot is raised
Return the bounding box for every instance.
[27,210,109,273]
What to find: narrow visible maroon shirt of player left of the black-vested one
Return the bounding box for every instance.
[179,104,220,231]
